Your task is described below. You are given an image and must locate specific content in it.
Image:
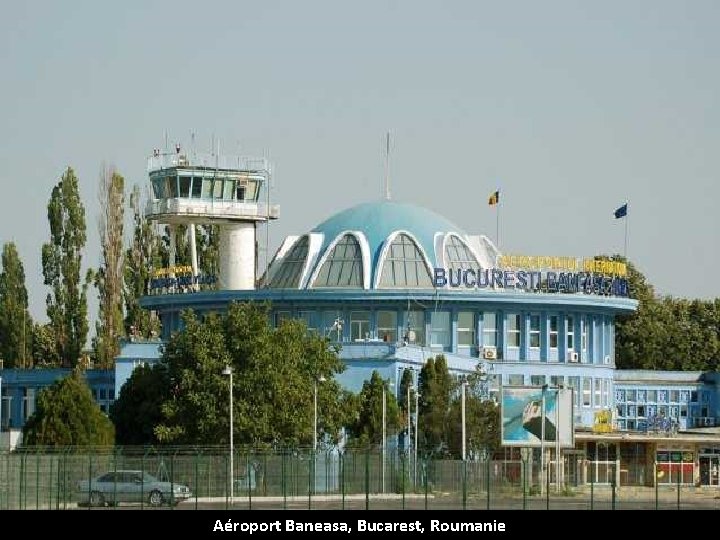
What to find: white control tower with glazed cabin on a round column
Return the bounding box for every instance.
[145,145,279,289]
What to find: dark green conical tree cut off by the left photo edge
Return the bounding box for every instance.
[0,242,33,368]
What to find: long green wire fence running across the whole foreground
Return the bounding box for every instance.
[0,446,720,510]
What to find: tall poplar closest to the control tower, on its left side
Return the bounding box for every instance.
[124,184,160,338]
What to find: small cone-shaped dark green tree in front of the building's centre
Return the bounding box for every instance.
[350,371,402,446]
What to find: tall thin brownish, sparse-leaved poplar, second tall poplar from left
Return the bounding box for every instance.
[94,168,125,368]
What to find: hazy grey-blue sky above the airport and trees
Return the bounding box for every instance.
[0,0,720,330]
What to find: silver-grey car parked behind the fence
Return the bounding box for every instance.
[77,470,192,506]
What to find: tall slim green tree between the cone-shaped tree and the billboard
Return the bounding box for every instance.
[418,354,453,454]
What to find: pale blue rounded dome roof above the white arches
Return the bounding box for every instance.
[312,201,466,268]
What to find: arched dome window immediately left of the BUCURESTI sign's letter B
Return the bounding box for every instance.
[378,233,432,289]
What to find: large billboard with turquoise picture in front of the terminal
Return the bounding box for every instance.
[500,386,575,448]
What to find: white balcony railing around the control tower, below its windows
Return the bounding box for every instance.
[145,199,280,220]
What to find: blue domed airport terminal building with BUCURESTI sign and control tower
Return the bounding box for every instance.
[0,152,720,485]
